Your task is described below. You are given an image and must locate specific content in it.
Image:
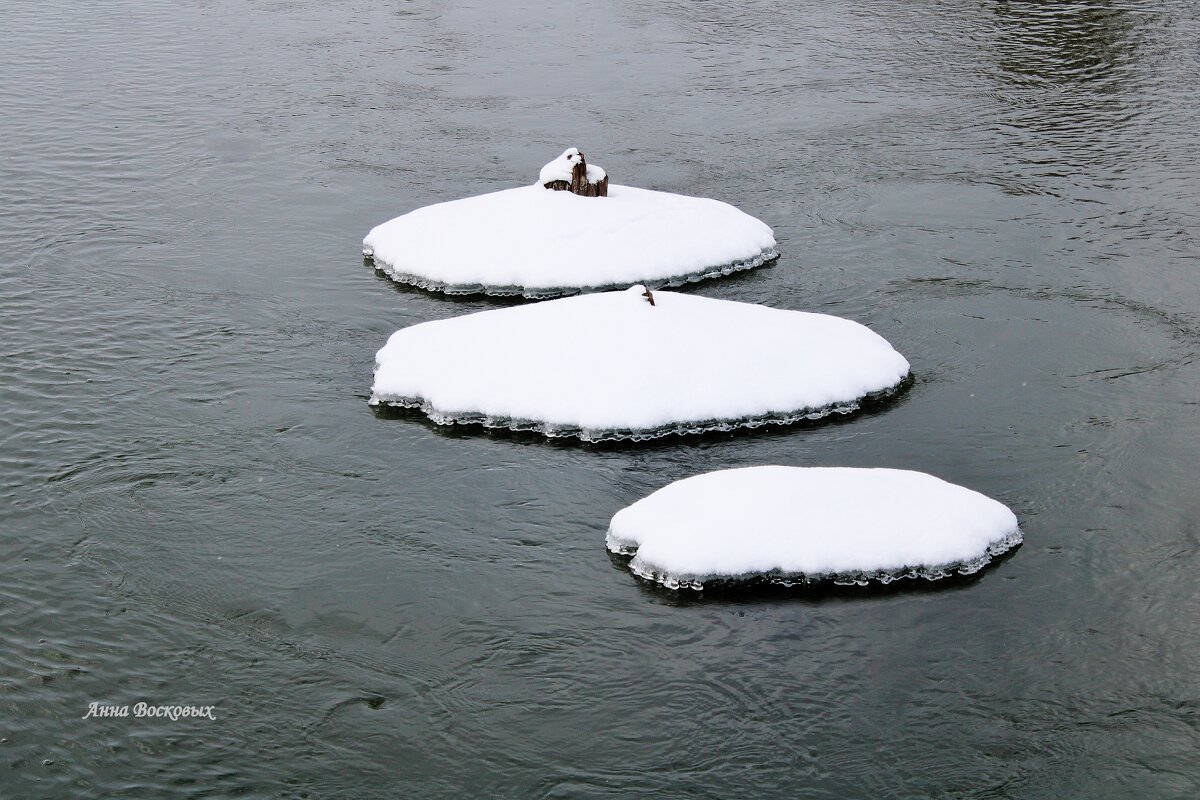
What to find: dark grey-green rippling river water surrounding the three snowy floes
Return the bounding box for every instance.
[0,0,1200,800]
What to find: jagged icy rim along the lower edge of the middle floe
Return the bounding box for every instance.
[370,372,913,443]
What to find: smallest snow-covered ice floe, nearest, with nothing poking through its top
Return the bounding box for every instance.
[606,467,1021,589]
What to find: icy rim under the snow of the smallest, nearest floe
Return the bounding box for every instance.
[605,529,1025,591]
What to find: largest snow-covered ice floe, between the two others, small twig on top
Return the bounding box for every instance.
[371,285,908,441]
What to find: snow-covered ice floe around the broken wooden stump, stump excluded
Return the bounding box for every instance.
[362,186,779,297]
